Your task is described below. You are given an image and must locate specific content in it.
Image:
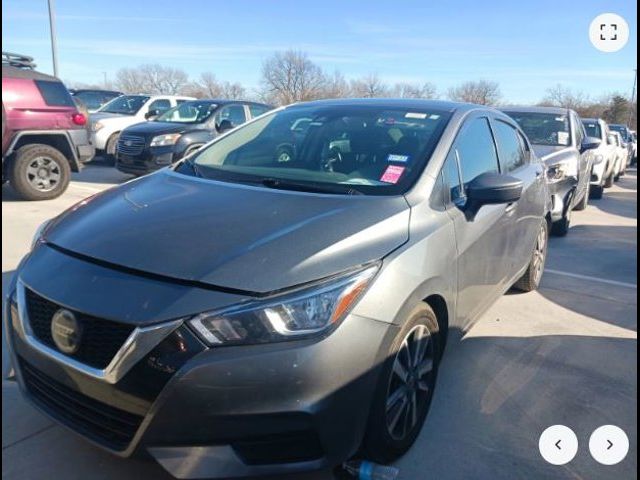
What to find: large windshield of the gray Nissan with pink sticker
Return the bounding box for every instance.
[179,106,450,195]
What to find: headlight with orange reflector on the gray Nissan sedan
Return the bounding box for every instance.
[189,265,378,346]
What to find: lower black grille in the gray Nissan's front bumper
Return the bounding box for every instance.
[20,359,143,450]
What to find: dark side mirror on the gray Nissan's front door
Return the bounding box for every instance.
[465,173,523,220]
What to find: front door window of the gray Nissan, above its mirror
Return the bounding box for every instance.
[454,118,500,187]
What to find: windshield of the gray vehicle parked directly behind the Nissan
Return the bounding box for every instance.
[507,112,571,147]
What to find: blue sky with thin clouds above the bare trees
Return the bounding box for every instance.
[2,0,637,102]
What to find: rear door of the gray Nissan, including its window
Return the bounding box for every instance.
[491,118,546,275]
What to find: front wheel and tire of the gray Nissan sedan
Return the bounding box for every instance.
[362,302,440,463]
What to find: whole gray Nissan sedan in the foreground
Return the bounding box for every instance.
[4,99,550,478]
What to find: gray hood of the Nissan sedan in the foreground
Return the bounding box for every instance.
[45,169,409,293]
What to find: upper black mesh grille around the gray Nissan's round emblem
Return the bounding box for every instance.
[25,288,134,369]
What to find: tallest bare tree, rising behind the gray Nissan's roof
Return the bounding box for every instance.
[262,50,325,105]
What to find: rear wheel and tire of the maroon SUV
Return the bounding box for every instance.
[9,143,71,200]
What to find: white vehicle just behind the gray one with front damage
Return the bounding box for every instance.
[582,118,618,199]
